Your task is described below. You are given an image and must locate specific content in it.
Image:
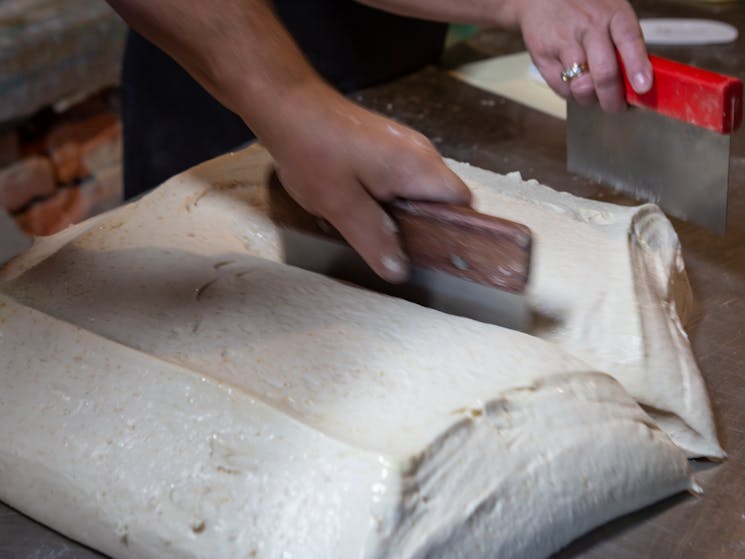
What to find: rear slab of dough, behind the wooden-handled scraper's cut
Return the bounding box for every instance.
[0,146,724,458]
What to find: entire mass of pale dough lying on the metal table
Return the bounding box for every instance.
[0,147,708,558]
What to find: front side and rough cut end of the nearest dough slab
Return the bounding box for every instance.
[0,297,694,559]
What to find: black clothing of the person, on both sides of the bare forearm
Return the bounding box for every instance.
[122,0,447,198]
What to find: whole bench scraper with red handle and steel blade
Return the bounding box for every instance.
[567,56,743,233]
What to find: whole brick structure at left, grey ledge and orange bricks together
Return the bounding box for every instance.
[0,0,126,235]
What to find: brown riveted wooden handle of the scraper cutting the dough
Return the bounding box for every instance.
[386,200,532,293]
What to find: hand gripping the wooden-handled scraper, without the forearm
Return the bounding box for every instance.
[260,83,471,282]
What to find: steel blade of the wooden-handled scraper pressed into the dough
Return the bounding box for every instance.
[280,228,531,332]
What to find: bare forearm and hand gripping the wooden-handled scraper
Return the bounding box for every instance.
[109,0,470,281]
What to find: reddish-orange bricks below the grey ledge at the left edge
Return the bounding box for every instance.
[0,91,123,235]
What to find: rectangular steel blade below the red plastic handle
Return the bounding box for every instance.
[567,102,730,233]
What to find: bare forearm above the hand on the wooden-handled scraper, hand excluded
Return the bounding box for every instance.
[108,0,331,138]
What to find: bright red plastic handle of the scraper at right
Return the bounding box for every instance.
[623,55,743,134]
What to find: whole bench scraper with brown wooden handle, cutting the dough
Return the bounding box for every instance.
[269,175,532,331]
